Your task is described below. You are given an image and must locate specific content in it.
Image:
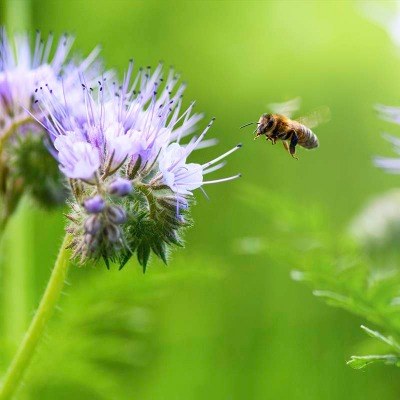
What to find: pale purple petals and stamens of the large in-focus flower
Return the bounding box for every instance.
[41,64,238,194]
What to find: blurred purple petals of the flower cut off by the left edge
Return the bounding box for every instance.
[0,27,99,136]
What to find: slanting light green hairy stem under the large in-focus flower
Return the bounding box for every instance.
[0,234,70,400]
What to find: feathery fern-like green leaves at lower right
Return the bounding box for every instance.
[241,184,400,369]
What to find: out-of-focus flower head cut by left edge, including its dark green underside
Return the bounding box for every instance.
[0,28,100,212]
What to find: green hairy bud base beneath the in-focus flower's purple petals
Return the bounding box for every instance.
[67,180,189,272]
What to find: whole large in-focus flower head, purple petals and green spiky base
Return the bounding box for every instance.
[39,62,240,268]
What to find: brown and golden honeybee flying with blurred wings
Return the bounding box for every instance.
[241,99,329,159]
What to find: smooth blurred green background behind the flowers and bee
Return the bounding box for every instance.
[0,0,400,400]
